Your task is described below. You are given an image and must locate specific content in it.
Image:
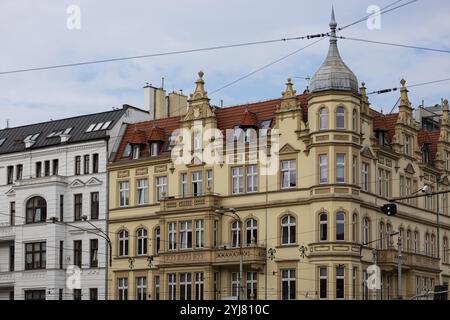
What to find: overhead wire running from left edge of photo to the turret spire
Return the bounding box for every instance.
[0,34,326,75]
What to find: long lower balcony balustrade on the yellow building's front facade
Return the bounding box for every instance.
[159,246,266,267]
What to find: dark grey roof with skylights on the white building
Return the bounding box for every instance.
[0,105,134,154]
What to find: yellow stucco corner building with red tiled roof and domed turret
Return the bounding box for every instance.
[104,10,450,300]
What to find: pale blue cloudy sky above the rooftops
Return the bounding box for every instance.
[0,0,450,128]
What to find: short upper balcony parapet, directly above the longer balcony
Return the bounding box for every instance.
[160,193,220,211]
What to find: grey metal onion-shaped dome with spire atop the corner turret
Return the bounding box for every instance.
[310,9,359,93]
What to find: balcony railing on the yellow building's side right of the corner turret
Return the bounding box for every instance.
[378,249,440,272]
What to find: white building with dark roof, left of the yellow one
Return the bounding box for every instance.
[0,105,148,300]
